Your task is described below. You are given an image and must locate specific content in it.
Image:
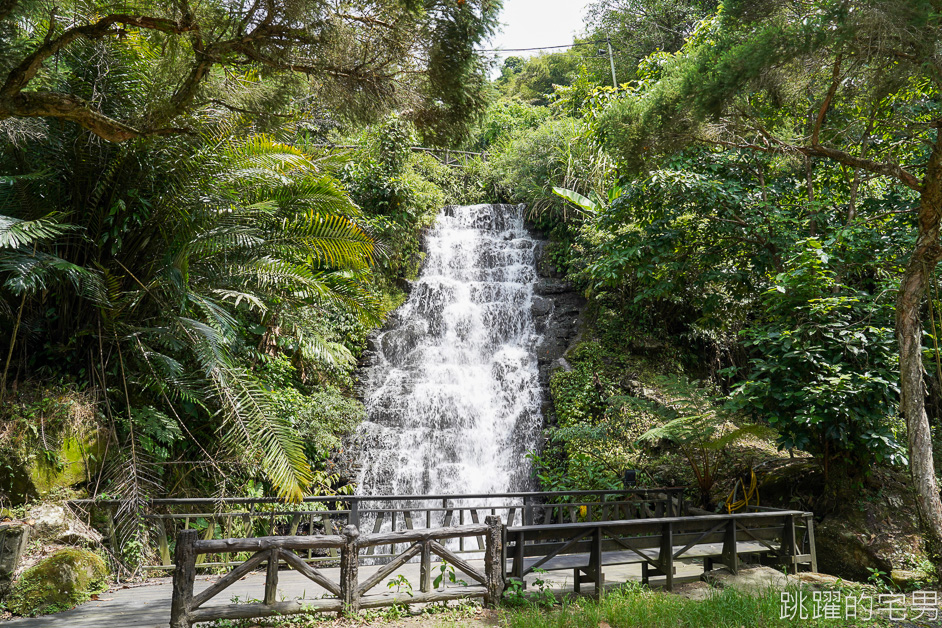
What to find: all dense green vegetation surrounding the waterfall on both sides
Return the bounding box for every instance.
[0,0,942,588]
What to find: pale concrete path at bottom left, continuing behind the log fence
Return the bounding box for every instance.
[0,560,702,628]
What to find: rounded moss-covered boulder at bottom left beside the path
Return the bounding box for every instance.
[7,548,108,615]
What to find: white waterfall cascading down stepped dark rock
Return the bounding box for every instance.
[357,205,541,495]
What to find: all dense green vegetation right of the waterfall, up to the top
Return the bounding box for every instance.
[481,0,942,576]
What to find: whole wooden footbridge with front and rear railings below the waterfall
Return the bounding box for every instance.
[73,488,816,628]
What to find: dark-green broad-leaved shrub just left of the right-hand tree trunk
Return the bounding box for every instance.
[734,239,906,467]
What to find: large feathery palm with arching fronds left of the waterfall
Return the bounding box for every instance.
[0,125,377,506]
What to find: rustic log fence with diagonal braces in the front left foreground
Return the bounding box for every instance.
[170,516,504,628]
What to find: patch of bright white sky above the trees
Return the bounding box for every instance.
[489,0,591,63]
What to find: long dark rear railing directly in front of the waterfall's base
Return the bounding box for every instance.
[70,488,686,571]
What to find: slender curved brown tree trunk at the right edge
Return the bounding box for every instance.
[896,132,942,574]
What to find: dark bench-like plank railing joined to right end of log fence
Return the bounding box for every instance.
[504,509,817,590]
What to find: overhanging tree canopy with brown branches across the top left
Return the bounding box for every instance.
[0,0,500,142]
